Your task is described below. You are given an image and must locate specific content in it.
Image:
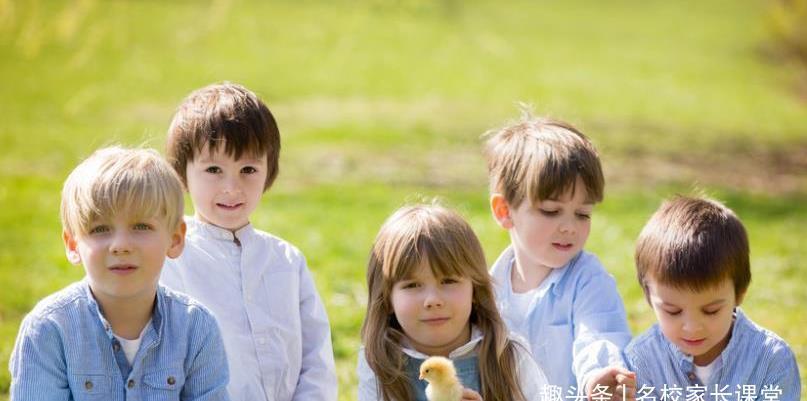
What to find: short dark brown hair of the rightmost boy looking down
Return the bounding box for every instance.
[636,196,751,299]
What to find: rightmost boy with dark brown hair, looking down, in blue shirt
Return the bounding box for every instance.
[625,197,801,400]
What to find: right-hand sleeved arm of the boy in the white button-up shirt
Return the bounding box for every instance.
[293,258,337,401]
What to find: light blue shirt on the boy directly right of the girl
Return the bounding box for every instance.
[490,247,631,394]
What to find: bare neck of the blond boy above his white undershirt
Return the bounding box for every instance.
[95,293,156,340]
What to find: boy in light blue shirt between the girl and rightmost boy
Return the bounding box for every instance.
[487,112,635,400]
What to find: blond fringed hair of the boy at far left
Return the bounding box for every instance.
[61,146,184,235]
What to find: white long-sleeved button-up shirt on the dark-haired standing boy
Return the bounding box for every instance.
[160,217,337,401]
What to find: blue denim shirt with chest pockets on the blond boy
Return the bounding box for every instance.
[9,280,229,401]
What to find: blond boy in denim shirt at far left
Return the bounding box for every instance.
[9,147,229,401]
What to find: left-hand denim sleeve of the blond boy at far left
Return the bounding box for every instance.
[9,315,72,401]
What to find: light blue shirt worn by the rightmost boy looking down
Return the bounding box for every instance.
[625,308,801,401]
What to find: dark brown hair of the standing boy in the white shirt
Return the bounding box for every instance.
[166,82,280,191]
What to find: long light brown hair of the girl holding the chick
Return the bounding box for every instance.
[361,205,524,401]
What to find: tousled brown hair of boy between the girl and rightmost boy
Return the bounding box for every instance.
[484,107,605,207]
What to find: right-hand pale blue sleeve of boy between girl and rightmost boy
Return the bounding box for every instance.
[572,261,631,389]
